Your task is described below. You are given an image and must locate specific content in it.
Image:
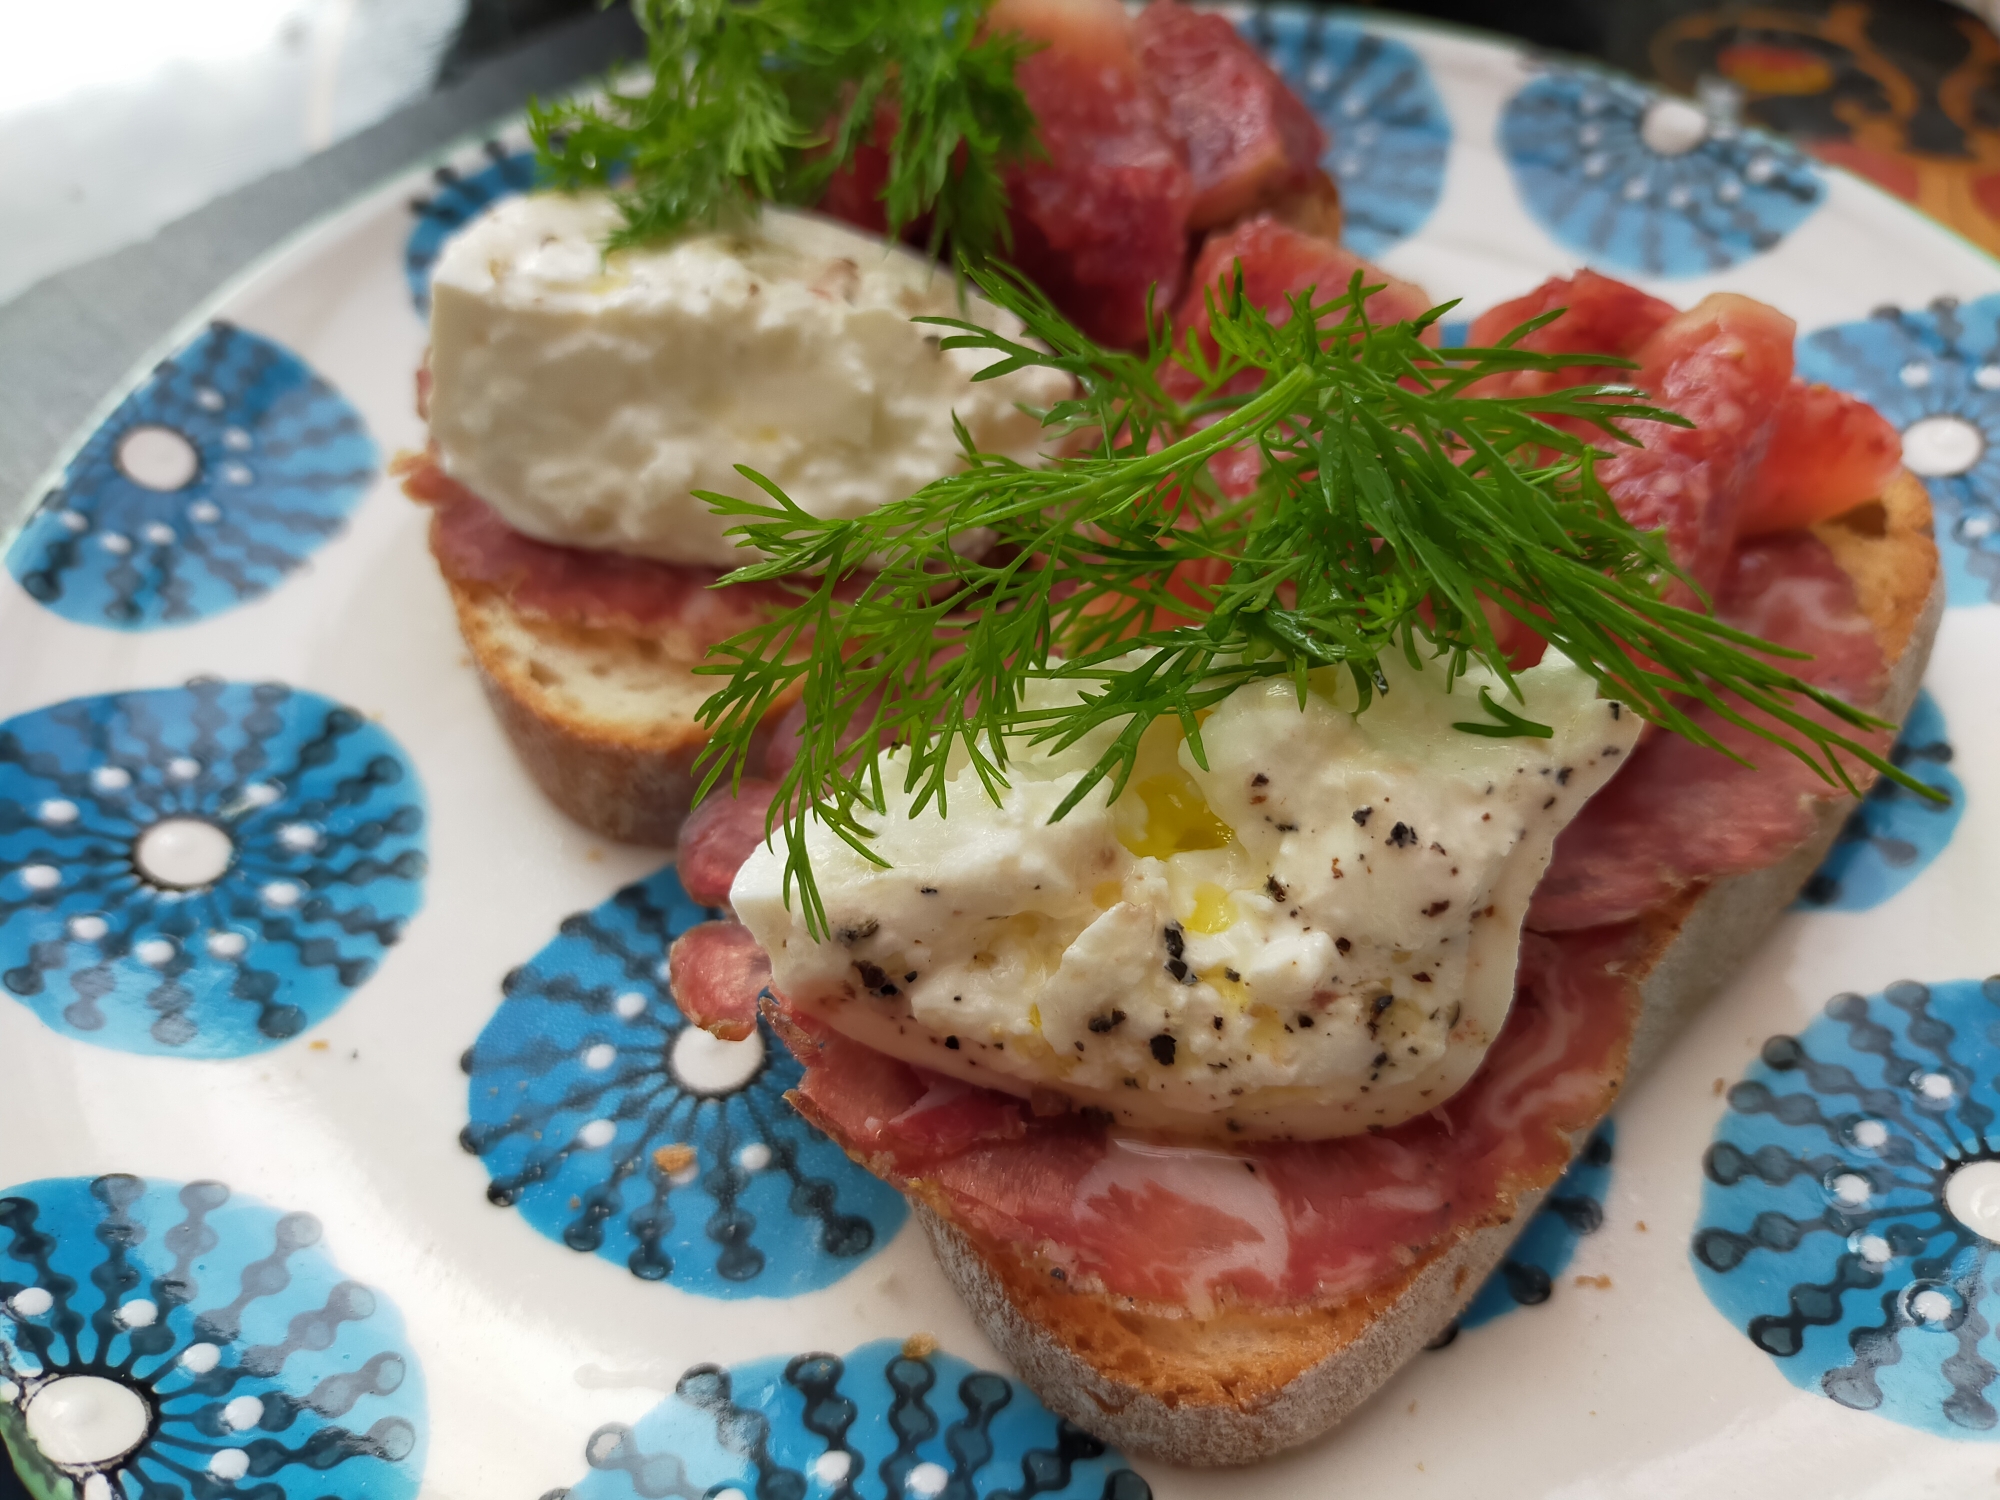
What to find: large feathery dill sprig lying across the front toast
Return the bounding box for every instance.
[698,266,1896,936]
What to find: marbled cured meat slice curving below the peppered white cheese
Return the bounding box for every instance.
[776,928,1644,1310]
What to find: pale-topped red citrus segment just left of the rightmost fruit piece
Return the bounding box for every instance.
[1598,292,1796,602]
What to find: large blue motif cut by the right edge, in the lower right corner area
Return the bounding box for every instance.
[1692,978,2000,1440]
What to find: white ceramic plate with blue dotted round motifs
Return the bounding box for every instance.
[0,10,2000,1500]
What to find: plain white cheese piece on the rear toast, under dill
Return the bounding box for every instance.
[430,194,1068,566]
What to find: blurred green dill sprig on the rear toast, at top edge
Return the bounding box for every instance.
[528,0,1036,258]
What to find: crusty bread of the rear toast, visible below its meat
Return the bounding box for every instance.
[448,580,788,844]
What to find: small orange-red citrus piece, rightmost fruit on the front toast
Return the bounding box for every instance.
[1736,376,1902,536]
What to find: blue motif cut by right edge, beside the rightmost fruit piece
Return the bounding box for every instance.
[1798,296,2000,604]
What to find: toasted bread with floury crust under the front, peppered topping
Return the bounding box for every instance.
[914,474,1944,1466]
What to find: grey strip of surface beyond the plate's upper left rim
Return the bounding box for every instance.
[0,8,642,540]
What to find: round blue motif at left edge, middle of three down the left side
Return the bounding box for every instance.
[0,678,426,1058]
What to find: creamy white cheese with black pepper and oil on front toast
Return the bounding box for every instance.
[730,652,1640,1138]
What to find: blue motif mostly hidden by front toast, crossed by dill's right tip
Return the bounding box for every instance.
[1798,692,1966,912]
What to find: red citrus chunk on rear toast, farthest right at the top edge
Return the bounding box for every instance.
[1132,0,1326,230]
